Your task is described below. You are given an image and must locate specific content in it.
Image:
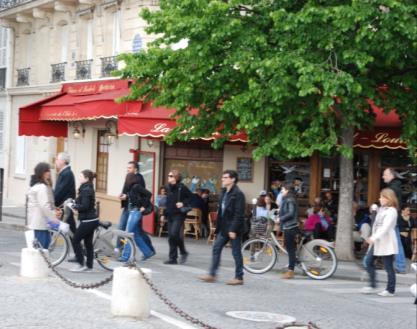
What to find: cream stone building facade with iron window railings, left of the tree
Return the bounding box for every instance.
[0,0,266,232]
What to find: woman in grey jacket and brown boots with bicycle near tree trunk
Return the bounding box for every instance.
[279,183,299,279]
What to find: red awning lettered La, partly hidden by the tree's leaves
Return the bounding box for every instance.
[118,103,247,142]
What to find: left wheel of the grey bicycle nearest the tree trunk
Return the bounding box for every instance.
[242,239,277,274]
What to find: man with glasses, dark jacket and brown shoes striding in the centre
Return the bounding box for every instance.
[199,170,246,286]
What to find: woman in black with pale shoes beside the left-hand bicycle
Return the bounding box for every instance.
[70,169,98,272]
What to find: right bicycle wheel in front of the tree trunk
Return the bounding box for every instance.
[299,240,337,280]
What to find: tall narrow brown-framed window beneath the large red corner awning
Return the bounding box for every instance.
[96,130,110,192]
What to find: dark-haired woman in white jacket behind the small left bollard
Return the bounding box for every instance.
[27,162,57,249]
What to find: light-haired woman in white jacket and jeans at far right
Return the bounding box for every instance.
[362,188,398,297]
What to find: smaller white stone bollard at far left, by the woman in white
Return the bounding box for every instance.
[20,248,49,279]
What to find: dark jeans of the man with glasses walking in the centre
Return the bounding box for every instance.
[210,232,243,280]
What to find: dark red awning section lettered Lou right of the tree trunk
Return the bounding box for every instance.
[354,128,407,149]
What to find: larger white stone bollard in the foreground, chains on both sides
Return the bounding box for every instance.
[111,267,152,320]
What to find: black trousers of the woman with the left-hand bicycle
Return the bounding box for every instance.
[72,220,98,268]
